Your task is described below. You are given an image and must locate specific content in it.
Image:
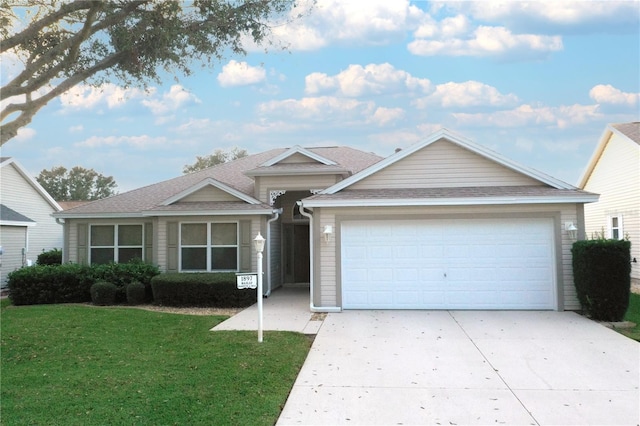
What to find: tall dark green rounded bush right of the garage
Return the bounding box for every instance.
[571,239,631,321]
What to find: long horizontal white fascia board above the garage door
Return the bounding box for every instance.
[303,195,598,208]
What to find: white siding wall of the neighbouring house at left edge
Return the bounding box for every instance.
[0,163,63,262]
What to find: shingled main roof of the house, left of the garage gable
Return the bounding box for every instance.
[55,147,382,217]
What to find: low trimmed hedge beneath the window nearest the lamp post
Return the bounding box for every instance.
[151,272,257,308]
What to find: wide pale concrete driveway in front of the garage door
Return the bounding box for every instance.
[278,311,640,425]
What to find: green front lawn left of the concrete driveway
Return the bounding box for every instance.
[0,300,311,425]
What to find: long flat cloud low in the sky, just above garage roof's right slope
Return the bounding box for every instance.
[453,104,602,129]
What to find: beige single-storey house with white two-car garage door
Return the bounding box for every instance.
[55,130,598,312]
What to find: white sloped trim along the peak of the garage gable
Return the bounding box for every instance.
[322,129,575,194]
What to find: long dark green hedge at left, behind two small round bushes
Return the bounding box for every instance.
[7,261,160,305]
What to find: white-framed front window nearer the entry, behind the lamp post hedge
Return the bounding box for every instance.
[180,222,238,272]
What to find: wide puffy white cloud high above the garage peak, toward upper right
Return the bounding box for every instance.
[407,26,563,58]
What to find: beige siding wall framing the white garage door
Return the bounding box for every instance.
[314,204,582,310]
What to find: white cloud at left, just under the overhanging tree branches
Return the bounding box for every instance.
[60,83,145,109]
